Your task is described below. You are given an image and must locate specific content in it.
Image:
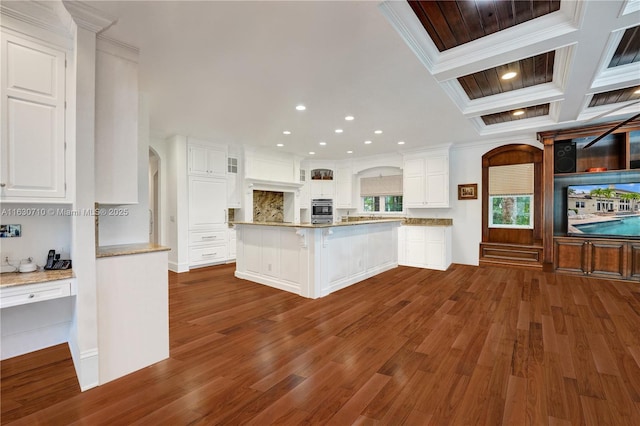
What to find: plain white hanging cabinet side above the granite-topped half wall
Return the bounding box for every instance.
[95,37,138,204]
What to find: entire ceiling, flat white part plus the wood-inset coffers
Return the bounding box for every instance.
[12,0,640,159]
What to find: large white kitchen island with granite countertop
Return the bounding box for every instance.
[234,219,402,299]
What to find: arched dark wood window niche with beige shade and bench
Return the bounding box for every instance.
[480,144,544,268]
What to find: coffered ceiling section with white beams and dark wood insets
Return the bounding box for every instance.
[382,0,640,134]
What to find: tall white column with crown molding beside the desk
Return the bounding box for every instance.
[64,1,114,391]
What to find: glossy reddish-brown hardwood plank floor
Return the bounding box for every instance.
[1,265,640,425]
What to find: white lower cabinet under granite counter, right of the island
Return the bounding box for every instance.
[398,226,451,271]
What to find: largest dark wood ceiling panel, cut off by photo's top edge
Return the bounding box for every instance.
[409,0,560,52]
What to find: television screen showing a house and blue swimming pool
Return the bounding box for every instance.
[567,183,640,239]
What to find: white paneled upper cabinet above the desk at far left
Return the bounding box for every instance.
[0,31,70,202]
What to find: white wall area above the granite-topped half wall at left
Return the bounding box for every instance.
[98,94,149,246]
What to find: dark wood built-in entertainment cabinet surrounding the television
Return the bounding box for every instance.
[538,122,640,281]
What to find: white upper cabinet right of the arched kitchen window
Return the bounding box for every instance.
[403,150,449,208]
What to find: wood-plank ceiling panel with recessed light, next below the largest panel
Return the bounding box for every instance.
[458,51,555,99]
